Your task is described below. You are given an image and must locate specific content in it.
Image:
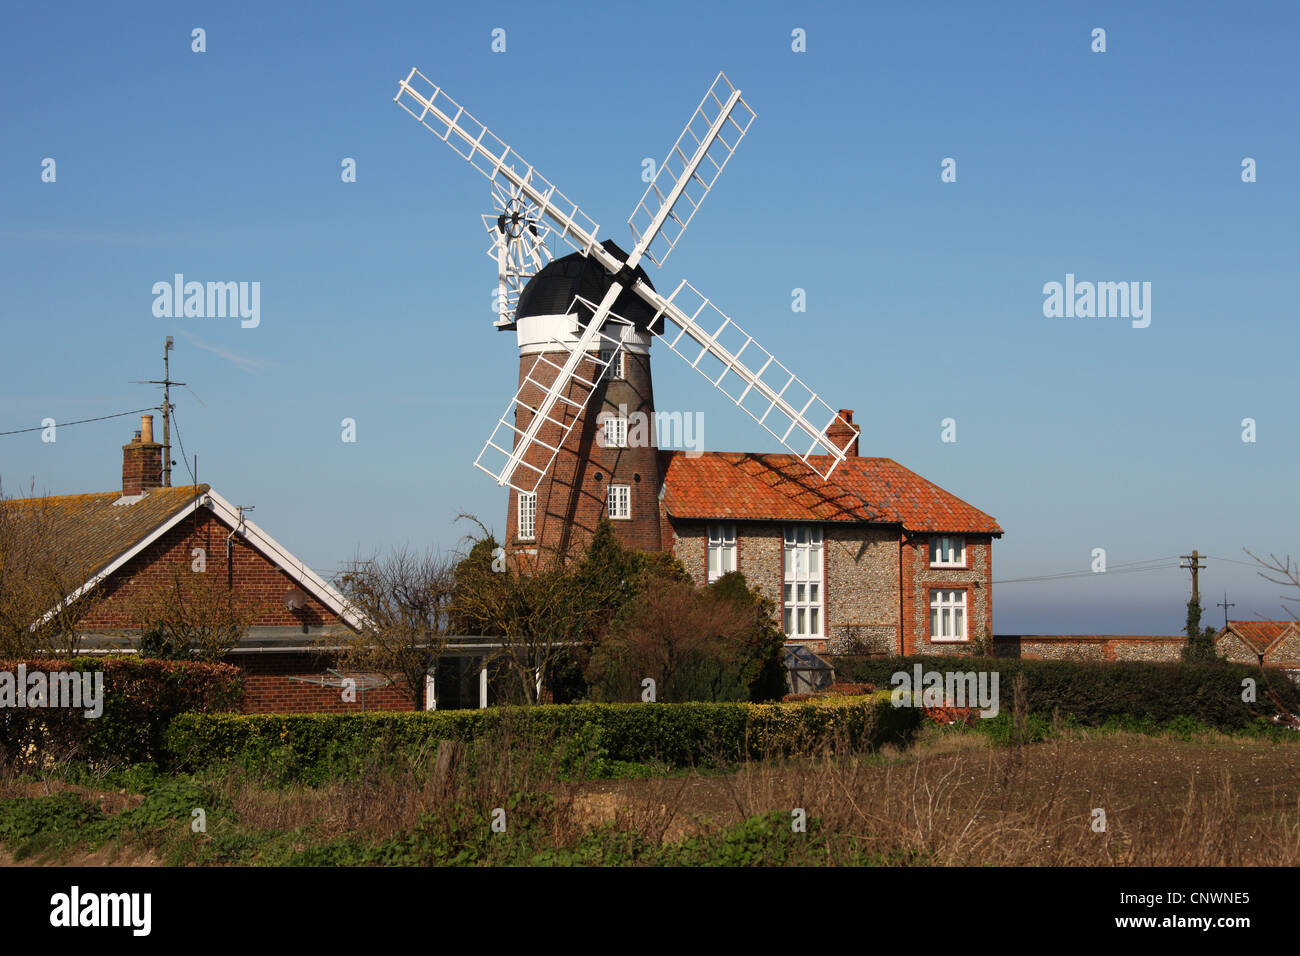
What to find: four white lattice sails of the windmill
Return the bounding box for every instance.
[394,69,863,490]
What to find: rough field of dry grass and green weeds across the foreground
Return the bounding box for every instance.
[0,726,1300,866]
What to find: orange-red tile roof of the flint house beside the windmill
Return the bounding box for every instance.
[660,451,1002,535]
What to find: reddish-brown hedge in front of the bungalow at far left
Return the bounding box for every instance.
[0,656,243,766]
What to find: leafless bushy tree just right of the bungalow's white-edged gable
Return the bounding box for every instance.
[335,548,456,708]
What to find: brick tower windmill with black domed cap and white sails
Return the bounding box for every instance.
[394,69,853,548]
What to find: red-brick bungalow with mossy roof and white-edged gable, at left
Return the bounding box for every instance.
[5,415,412,713]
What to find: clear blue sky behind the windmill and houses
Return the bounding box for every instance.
[0,3,1300,633]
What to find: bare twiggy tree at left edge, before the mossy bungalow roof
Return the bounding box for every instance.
[0,485,103,657]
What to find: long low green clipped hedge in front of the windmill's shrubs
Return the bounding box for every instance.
[166,693,919,780]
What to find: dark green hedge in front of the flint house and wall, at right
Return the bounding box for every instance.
[833,657,1300,730]
